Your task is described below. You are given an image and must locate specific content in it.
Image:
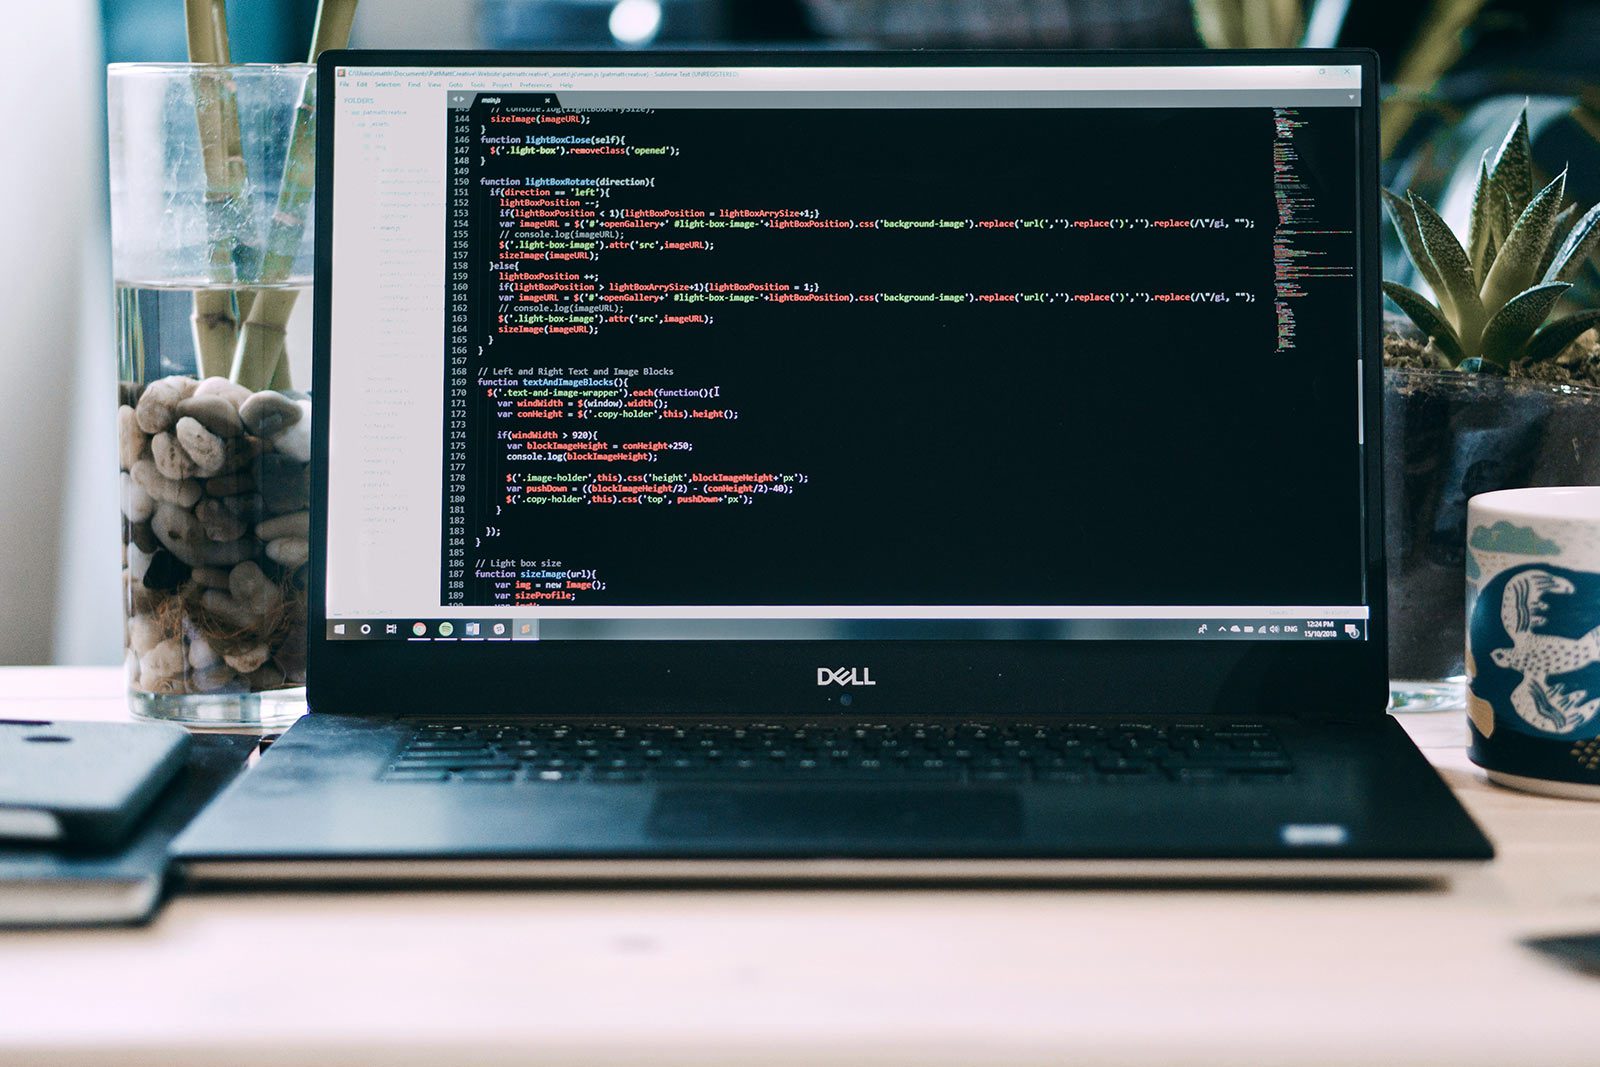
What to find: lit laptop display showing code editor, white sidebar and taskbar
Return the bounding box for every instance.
[323,59,1370,641]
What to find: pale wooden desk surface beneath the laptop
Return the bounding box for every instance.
[0,669,1600,1067]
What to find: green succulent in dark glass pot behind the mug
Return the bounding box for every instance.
[1384,109,1600,705]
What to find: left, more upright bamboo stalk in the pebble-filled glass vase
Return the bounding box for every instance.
[184,0,243,378]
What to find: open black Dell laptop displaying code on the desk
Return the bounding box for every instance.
[176,51,1491,881]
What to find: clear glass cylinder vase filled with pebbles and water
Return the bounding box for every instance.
[107,64,315,726]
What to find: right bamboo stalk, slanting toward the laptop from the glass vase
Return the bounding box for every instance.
[230,0,357,390]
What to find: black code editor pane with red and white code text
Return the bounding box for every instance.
[440,93,1362,606]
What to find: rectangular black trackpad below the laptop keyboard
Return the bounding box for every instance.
[646,785,1022,841]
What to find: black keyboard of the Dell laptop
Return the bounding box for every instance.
[382,720,1294,784]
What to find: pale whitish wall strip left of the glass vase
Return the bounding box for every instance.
[0,0,118,664]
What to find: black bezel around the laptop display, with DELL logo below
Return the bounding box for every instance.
[307,50,1387,718]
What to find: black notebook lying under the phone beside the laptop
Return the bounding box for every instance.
[0,734,258,926]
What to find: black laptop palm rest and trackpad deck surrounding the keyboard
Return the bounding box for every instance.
[174,713,1493,883]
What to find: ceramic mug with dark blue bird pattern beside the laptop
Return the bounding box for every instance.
[1466,486,1600,800]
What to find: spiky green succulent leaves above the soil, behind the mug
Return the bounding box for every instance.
[1384,107,1600,371]
